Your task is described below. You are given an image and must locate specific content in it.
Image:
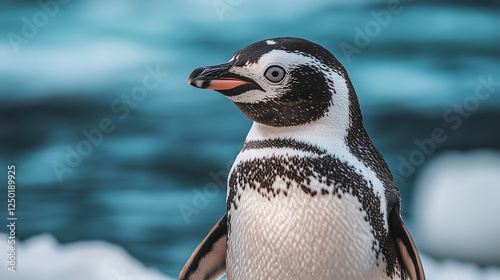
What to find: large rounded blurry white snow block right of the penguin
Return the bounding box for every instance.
[413,150,500,266]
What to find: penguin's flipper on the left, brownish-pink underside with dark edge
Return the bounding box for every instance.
[177,215,227,280]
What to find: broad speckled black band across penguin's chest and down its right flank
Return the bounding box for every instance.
[227,154,391,266]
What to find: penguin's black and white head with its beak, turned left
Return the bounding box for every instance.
[188,37,359,127]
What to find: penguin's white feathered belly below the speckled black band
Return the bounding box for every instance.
[226,177,387,280]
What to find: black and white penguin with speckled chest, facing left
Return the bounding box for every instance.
[178,37,425,280]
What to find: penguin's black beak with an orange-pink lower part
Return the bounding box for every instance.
[188,61,252,90]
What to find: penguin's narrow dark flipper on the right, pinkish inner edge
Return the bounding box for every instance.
[389,207,425,280]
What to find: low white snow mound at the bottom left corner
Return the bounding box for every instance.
[0,233,171,280]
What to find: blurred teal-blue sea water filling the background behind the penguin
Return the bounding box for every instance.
[0,0,500,279]
